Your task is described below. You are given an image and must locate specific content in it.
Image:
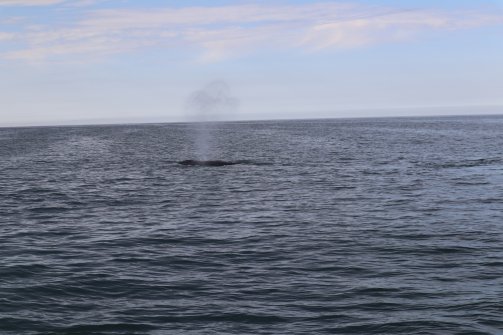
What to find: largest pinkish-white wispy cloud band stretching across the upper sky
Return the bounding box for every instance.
[0,0,503,61]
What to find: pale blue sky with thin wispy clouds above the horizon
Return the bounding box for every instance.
[0,0,503,126]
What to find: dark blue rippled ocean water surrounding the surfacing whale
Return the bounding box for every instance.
[0,116,503,334]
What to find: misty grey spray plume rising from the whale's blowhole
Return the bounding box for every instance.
[186,81,238,161]
